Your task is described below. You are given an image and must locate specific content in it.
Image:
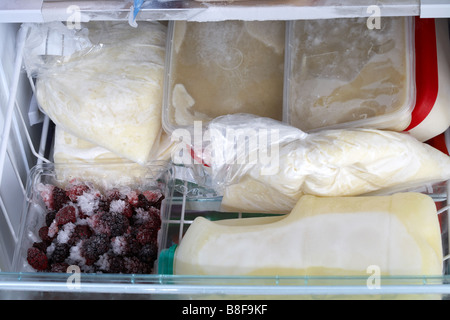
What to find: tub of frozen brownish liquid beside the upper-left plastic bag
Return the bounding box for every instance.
[163,21,286,133]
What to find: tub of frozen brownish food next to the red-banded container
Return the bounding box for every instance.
[284,17,415,131]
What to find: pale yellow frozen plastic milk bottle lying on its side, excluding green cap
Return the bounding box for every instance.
[173,192,443,276]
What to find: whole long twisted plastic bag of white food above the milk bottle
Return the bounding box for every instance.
[177,114,450,213]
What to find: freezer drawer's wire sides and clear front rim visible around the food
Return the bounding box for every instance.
[0,19,450,298]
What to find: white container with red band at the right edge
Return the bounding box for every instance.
[406,18,450,141]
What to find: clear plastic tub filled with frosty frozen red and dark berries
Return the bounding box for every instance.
[13,162,171,274]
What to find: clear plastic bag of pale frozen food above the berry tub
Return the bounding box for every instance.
[24,22,166,164]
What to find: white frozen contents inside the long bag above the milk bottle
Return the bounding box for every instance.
[223,129,450,213]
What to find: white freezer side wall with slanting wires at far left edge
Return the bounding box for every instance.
[0,23,42,271]
